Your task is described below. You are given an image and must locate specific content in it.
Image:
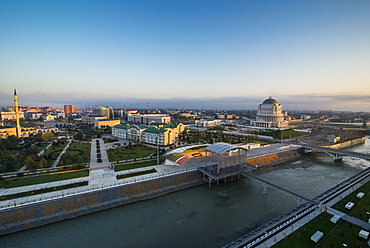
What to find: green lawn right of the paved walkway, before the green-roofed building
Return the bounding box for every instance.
[107,145,156,162]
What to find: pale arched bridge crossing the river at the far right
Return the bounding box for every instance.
[290,142,370,161]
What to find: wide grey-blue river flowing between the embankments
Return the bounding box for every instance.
[0,137,370,248]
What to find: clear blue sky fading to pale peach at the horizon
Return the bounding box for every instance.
[0,0,370,112]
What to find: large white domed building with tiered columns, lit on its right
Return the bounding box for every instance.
[252,96,289,128]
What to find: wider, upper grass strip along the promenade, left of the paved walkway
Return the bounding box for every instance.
[0,170,89,188]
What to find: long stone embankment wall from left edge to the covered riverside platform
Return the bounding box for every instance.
[0,171,205,235]
